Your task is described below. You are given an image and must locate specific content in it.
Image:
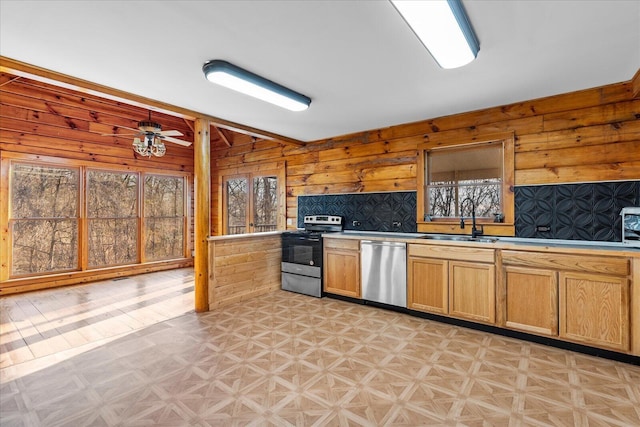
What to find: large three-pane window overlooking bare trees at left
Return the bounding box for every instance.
[0,159,188,280]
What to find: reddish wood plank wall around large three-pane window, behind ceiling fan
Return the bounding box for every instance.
[0,73,230,293]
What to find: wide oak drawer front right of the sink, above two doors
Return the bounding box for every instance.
[502,251,630,276]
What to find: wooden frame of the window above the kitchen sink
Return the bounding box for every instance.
[416,132,515,236]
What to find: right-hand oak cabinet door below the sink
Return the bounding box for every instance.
[449,261,496,323]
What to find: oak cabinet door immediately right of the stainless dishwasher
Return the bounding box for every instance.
[407,257,449,314]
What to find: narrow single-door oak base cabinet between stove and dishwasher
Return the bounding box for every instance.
[323,237,361,298]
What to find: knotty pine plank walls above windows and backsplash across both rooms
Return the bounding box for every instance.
[0,73,640,235]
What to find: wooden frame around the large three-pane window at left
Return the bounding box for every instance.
[0,152,193,282]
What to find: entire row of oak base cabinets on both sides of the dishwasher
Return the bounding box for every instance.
[324,237,640,354]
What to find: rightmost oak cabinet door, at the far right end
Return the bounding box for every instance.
[559,272,629,351]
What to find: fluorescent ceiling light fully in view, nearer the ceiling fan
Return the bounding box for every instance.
[202,59,311,111]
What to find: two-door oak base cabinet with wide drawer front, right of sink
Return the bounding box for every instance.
[501,250,630,351]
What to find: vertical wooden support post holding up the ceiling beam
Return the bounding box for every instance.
[193,119,211,313]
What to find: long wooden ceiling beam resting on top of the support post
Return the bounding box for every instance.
[0,56,304,145]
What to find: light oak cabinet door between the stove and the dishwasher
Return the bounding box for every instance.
[324,249,361,298]
